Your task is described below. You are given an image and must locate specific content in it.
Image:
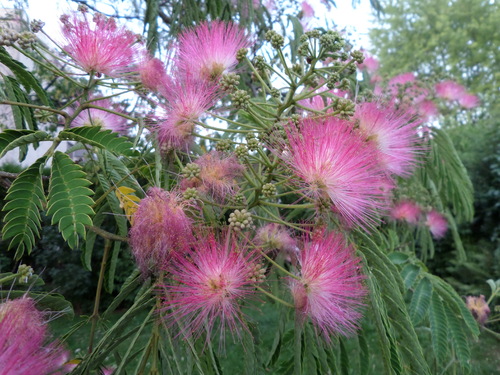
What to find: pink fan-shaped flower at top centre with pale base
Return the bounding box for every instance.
[177,21,250,81]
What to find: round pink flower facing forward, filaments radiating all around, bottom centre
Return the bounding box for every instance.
[165,235,255,341]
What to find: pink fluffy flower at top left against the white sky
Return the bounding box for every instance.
[61,13,137,77]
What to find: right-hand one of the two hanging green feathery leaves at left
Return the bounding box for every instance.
[47,152,94,248]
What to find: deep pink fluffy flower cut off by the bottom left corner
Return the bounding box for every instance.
[0,297,68,375]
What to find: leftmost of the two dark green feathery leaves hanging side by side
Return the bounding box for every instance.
[2,158,46,259]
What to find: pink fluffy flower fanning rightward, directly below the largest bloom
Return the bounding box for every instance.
[290,233,367,339]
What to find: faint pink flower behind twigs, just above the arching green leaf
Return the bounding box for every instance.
[71,99,128,134]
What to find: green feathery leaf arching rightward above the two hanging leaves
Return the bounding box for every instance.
[58,126,138,156]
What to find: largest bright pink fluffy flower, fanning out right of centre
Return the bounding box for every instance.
[282,117,388,227]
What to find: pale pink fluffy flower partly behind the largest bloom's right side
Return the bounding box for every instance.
[353,103,418,176]
